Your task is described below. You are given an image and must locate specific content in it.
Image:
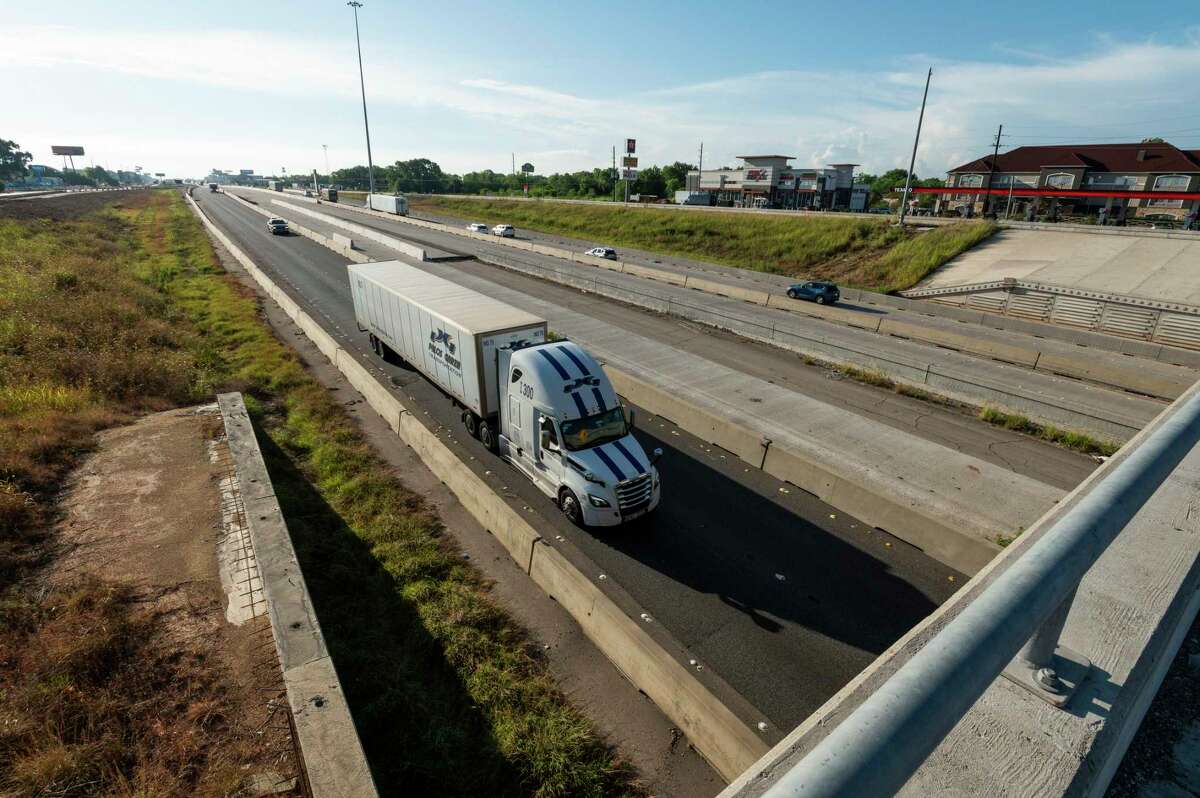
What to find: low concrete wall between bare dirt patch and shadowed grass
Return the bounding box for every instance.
[217,394,378,798]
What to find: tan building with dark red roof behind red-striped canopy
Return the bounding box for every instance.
[913,143,1200,220]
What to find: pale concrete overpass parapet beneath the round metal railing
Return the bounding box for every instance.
[721,379,1200,798]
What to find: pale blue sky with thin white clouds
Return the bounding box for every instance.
[7,0,1200,178]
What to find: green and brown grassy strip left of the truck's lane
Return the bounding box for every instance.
[0,192,637,796]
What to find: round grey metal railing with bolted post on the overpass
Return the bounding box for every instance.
[763,383,1200,798]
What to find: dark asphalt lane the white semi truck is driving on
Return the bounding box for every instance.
[197,192,965,742]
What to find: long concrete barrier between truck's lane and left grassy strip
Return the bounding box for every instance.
[192,194,768,782]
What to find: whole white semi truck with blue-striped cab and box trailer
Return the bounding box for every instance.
[348,262,662,527]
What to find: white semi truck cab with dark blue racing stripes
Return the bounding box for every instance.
[497,341,662,527]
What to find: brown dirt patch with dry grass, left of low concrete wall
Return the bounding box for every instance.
[0,406,299,796]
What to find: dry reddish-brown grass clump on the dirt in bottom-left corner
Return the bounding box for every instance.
[0,578,250,798]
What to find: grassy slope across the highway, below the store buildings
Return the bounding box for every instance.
[409,194,996,293]
